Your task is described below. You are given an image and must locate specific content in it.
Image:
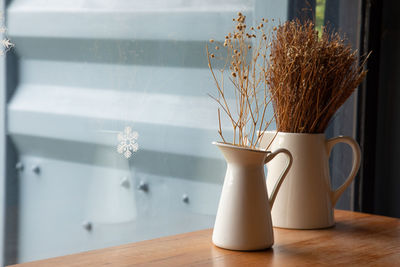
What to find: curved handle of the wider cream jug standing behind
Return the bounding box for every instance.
[326,136,361,207]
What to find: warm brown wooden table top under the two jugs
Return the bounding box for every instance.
[10,210,400,267]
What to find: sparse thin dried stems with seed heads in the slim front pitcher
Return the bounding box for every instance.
[206,12,276,148]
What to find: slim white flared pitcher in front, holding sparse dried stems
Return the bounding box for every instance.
[212,142,292,250]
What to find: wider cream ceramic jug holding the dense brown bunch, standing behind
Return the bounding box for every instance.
[260,132,361,229]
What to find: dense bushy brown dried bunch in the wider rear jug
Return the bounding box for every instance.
[267,20,369,133]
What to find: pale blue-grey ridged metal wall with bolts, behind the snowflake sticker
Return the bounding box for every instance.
[0,0,287,263]
